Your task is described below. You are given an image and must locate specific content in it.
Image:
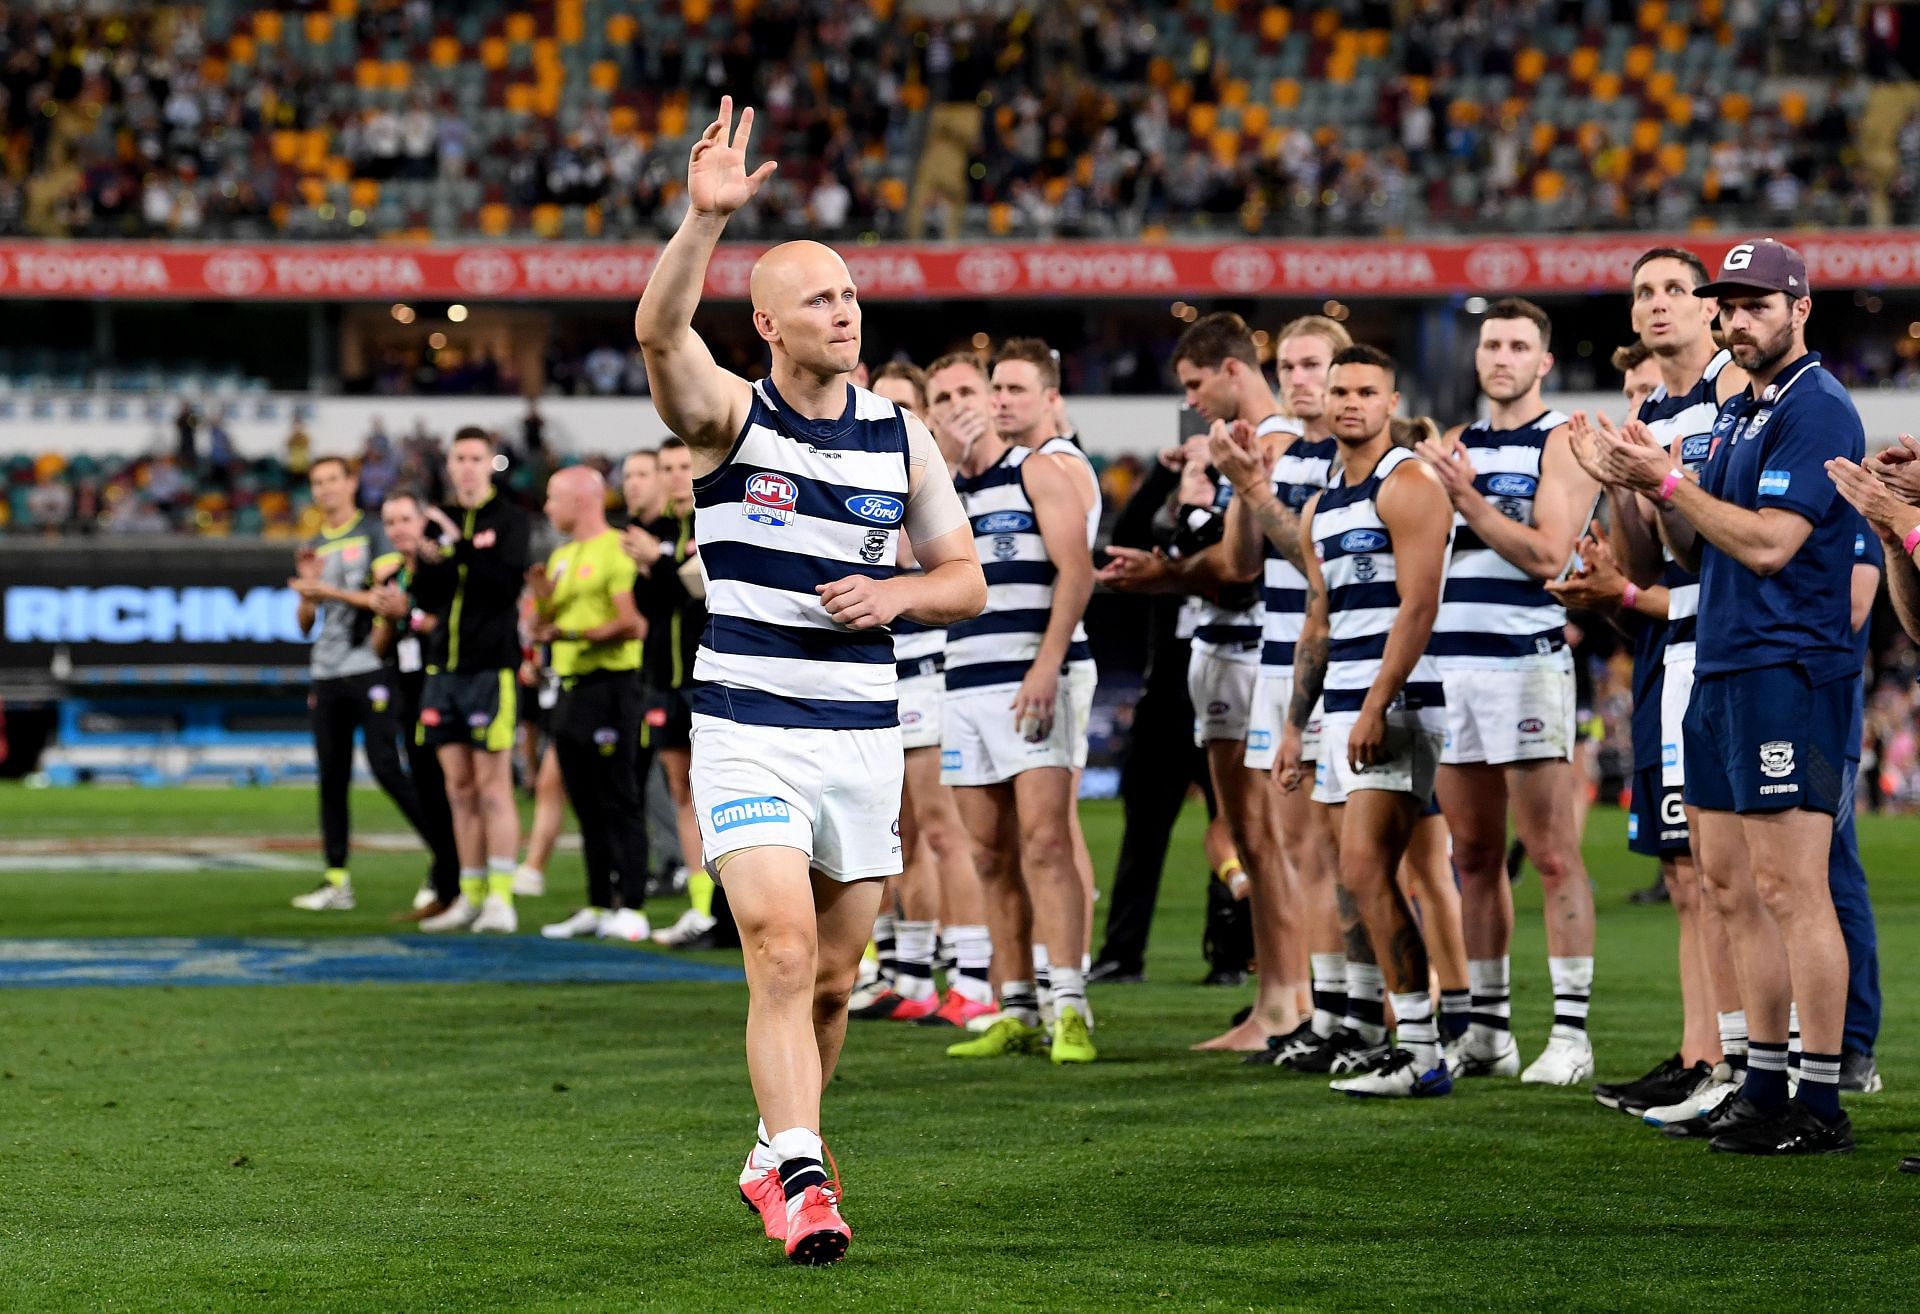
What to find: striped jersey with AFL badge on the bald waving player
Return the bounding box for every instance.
[691,378,908,730]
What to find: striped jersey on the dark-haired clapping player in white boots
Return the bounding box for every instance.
[1428,411,1567,669]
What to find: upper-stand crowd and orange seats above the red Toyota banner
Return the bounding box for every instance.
[0,0,1912,238]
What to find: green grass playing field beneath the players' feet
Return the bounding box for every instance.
[0,788,1920,1312]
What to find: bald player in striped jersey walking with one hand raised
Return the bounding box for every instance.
[634,96,987,1264]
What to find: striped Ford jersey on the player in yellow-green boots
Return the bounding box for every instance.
[947,448,1092,690]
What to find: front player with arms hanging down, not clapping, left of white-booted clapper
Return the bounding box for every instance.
[1281,346,1453,1099]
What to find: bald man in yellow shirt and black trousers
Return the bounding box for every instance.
[526,465,653,939]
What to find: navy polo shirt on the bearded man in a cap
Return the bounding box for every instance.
[1695,352,1866,686]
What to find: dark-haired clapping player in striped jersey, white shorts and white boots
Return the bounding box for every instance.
[1419,298,1597,1085]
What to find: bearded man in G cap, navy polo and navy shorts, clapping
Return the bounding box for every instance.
[1594,238,1866,1155]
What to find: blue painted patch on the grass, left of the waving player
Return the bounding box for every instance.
[0,936,741,987]
